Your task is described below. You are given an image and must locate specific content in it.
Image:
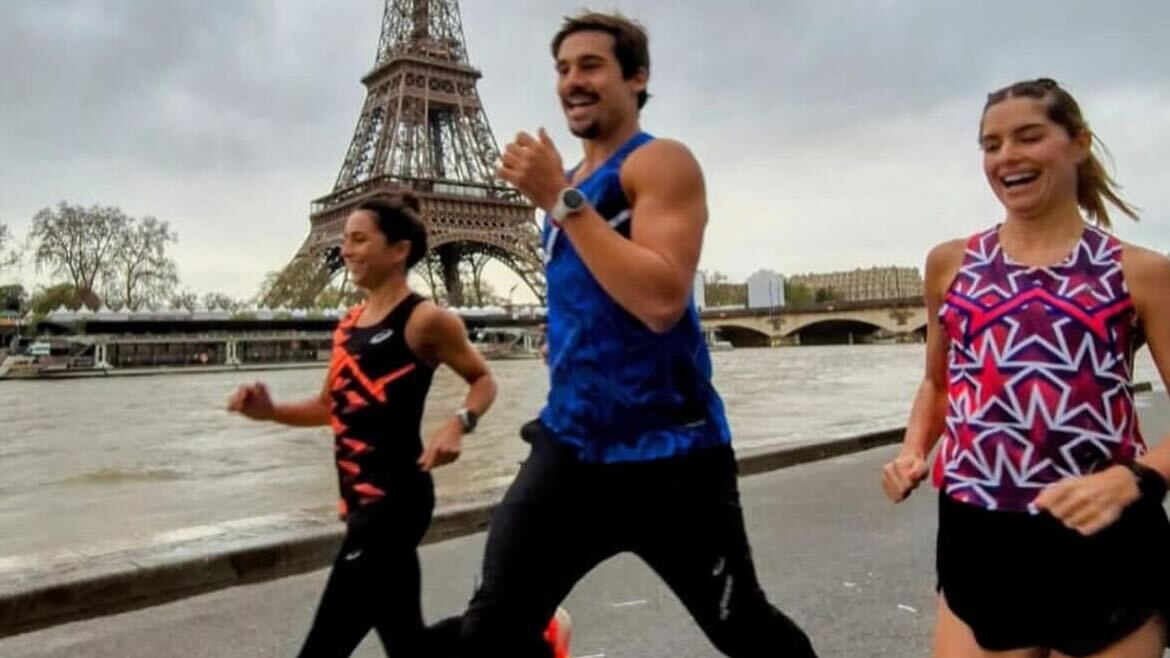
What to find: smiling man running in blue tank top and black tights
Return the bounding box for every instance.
[428,13,814,658]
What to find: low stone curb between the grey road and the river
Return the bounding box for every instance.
[0,430,903,637]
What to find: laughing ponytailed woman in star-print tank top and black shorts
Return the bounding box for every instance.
[882,78,1170,658]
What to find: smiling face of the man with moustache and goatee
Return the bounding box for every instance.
[557,29,647,139]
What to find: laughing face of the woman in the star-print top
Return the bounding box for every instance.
[979,96,1090,217]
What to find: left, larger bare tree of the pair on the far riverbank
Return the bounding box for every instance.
[29,201,130,308]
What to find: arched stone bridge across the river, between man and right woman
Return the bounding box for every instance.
[702,297,927,347]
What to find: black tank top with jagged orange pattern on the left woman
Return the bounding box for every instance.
[329,293,434,519]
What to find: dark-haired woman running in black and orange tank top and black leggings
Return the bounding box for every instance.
[228,196,496,658]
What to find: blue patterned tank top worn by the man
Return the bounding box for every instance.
[541,132,731,462]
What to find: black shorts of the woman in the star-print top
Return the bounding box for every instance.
[936,494,1170,656]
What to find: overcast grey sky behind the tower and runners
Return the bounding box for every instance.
[0,0,1170,296]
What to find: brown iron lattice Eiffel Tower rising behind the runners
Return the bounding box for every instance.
[266,0,544,308]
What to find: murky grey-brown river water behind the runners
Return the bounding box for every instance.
[0,345,1161,556]
